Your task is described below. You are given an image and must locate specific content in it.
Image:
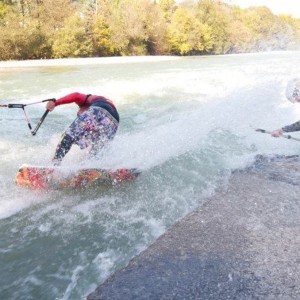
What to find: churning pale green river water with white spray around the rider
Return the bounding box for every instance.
[0,52,300,300]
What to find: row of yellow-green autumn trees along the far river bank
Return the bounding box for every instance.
[0,0,300,60]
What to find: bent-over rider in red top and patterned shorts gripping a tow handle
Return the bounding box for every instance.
[46,93,120,165]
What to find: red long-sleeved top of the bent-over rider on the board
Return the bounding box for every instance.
[55,93,116,114]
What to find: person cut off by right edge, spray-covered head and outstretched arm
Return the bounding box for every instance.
[271,78,300,137]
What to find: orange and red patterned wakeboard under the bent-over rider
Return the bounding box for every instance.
[16,165,141,190]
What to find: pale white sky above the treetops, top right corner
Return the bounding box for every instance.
[224,0,300,18]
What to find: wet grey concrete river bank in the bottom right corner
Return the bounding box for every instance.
[87,157,300,300]
